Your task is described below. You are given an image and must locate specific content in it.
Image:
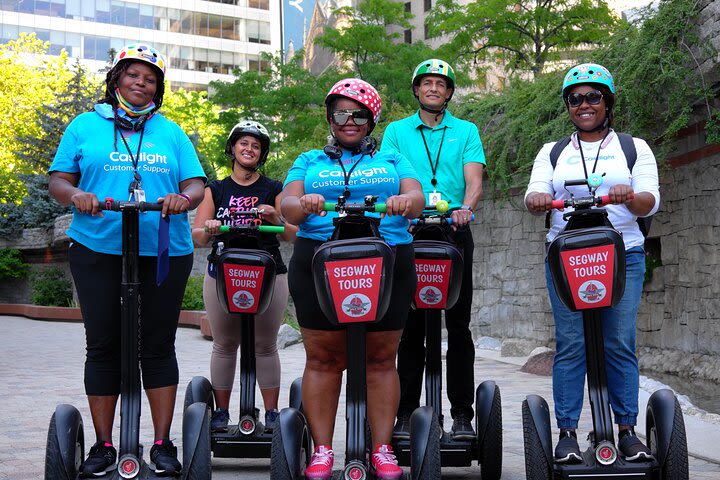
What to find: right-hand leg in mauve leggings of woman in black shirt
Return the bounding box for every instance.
[255,274,289,411]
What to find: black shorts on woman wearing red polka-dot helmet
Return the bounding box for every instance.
[288,237,417,332]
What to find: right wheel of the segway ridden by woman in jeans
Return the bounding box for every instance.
[646,396,690,480]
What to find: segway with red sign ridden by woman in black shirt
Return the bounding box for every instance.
[184,209,306,466]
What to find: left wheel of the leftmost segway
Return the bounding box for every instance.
[45,405,85,480]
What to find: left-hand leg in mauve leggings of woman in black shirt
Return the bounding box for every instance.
[203,272,241,412]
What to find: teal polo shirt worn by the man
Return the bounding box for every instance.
[382,110,485,208]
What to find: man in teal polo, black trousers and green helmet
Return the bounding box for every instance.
[382,59,485,440]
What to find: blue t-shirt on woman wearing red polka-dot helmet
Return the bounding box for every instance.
[285,150,418,245]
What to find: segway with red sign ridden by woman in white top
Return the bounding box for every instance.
[522,178,688,480]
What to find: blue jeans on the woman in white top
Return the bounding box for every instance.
[545,247,645,429]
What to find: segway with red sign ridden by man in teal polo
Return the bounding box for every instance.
[393,202,502,480]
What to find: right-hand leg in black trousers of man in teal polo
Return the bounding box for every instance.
[445,229,475,439]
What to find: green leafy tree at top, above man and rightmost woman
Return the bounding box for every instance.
[427,0,616,75]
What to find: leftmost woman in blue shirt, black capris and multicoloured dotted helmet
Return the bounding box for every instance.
[50,44,205,477]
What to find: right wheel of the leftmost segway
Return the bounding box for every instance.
[182,402,212,480]
